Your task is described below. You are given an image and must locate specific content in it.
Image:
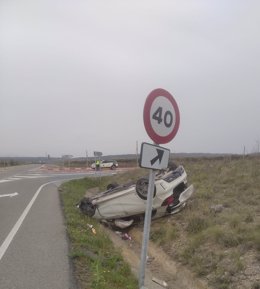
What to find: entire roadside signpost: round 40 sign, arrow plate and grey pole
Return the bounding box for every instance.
[139,88,180,289]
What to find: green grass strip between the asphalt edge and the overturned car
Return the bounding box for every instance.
[61,174,138,289]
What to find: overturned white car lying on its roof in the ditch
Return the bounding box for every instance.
[79,165,194,228]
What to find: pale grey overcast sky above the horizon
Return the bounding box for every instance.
[0,0,260,157]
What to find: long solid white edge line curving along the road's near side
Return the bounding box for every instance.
[0,180,57,261]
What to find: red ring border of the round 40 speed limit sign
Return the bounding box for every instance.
[143,88,180,144]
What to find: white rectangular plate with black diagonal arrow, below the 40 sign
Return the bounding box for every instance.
[140,143,170,170]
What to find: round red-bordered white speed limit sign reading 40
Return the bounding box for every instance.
[143,88,180,144]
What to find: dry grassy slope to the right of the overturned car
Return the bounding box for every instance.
[151,158,260,289]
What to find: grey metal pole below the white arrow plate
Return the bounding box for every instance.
[139,169,155,289]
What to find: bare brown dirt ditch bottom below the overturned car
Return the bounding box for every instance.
[106,225,208,289]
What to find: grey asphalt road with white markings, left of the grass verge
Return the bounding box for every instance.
[0,165,114,289]
